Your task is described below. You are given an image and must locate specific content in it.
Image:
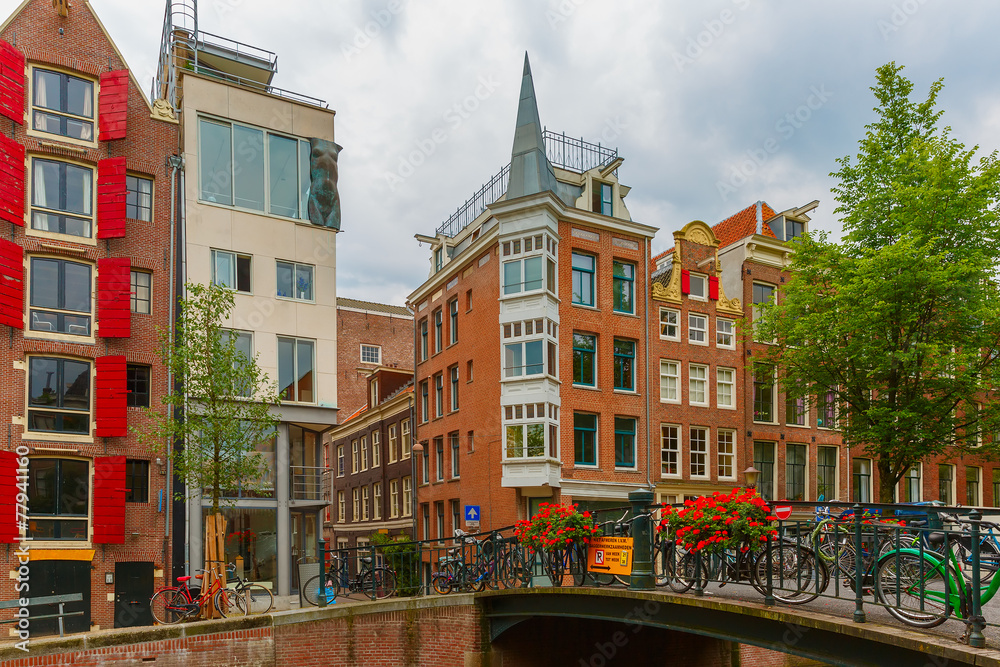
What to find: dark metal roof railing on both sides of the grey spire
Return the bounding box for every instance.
[437,130,618,237]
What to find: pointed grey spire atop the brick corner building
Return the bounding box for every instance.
[507,51,575,204]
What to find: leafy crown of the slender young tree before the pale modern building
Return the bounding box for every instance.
[138,284,279,515]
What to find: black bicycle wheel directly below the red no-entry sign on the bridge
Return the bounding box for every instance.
[752,543,830,604]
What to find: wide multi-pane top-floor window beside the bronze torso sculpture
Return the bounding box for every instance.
[199,118,312,219]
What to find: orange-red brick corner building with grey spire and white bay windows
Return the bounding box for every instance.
[408,54,655,538]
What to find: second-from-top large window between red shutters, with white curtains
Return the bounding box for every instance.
[31,158,94,239]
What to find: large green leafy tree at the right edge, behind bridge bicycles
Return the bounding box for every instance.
[753,63,1000,502]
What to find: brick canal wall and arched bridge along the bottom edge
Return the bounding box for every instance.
[0,588,1000,667]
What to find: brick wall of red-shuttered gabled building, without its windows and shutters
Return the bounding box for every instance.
[0,0,178,628]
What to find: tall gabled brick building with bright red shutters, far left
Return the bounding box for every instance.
[0,0,177,636]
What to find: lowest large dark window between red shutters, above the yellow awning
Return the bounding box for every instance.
[27,458,90,540]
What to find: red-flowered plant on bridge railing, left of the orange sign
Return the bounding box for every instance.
[514,503,601,586]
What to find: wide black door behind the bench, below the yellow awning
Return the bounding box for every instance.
[28,560,90,637]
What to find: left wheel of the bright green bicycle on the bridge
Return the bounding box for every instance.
[875,552,961,628]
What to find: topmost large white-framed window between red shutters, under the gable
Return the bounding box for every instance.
[31,67,94,141]
